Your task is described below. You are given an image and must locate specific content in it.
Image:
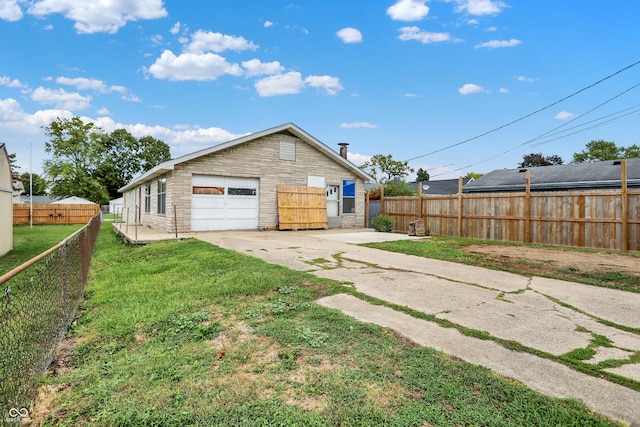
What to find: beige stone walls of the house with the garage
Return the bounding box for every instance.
[125,134,365,233]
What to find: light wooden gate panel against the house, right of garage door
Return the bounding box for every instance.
[278,185,329,230]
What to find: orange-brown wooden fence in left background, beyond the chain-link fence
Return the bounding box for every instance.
[13,204,100,225]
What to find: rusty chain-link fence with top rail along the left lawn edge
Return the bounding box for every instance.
[0,215,100,421]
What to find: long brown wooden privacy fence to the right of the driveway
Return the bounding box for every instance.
[381,174,640,252]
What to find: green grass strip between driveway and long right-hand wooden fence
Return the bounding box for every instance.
[363,236,640,292]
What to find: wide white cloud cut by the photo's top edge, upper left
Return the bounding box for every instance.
[28,0,167,34]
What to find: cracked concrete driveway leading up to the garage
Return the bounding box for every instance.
[194,229,640,426]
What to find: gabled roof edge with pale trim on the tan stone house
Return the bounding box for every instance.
[118,123,375,193]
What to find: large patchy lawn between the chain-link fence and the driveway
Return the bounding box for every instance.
[31,224,618,426]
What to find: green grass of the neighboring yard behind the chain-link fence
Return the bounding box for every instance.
[0,224,84,275]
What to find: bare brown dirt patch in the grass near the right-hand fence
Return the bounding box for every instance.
[465,245,640,276]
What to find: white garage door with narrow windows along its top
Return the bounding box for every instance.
[191,175,259,231]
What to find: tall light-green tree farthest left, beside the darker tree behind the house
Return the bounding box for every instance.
[43,117,109,204]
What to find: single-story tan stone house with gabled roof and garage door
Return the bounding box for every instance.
[119,123,374,232]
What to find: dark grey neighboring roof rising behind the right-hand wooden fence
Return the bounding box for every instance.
[462,158,640,193]
